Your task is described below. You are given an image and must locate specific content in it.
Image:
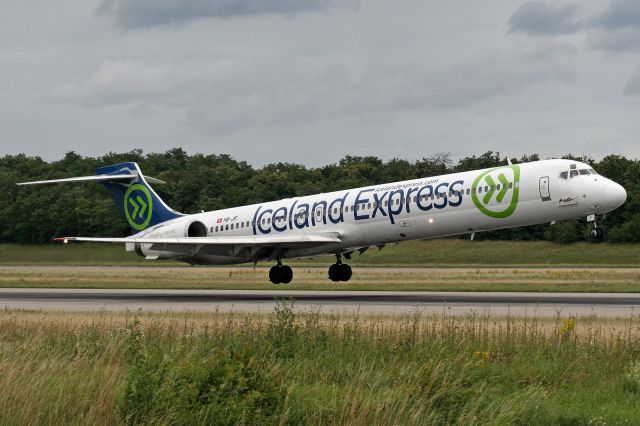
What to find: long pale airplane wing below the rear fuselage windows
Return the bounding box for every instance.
[55,232,341,258]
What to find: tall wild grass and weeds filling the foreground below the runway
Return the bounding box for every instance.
[0,302,640,425]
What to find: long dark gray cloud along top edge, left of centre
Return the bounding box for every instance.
[97,0,335,29]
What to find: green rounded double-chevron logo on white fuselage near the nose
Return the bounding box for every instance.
[471,166,520,219]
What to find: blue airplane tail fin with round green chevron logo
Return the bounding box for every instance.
[96,162,182,231]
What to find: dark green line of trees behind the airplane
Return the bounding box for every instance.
[0,148,640,244]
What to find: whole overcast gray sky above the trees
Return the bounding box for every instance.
[0,0,640,166]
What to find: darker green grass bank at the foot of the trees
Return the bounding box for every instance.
[0,239,640,267]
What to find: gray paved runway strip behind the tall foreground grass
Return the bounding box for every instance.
[0,288,640,317]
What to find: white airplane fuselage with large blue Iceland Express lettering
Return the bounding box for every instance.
[137,160,626,264]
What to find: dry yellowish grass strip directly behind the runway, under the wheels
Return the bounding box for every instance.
[0,266,640,292]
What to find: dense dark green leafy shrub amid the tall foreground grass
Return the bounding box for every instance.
[119,322,283,425]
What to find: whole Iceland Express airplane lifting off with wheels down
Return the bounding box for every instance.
[18,159,627,284]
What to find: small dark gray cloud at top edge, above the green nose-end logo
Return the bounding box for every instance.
[508,1,581,35]
